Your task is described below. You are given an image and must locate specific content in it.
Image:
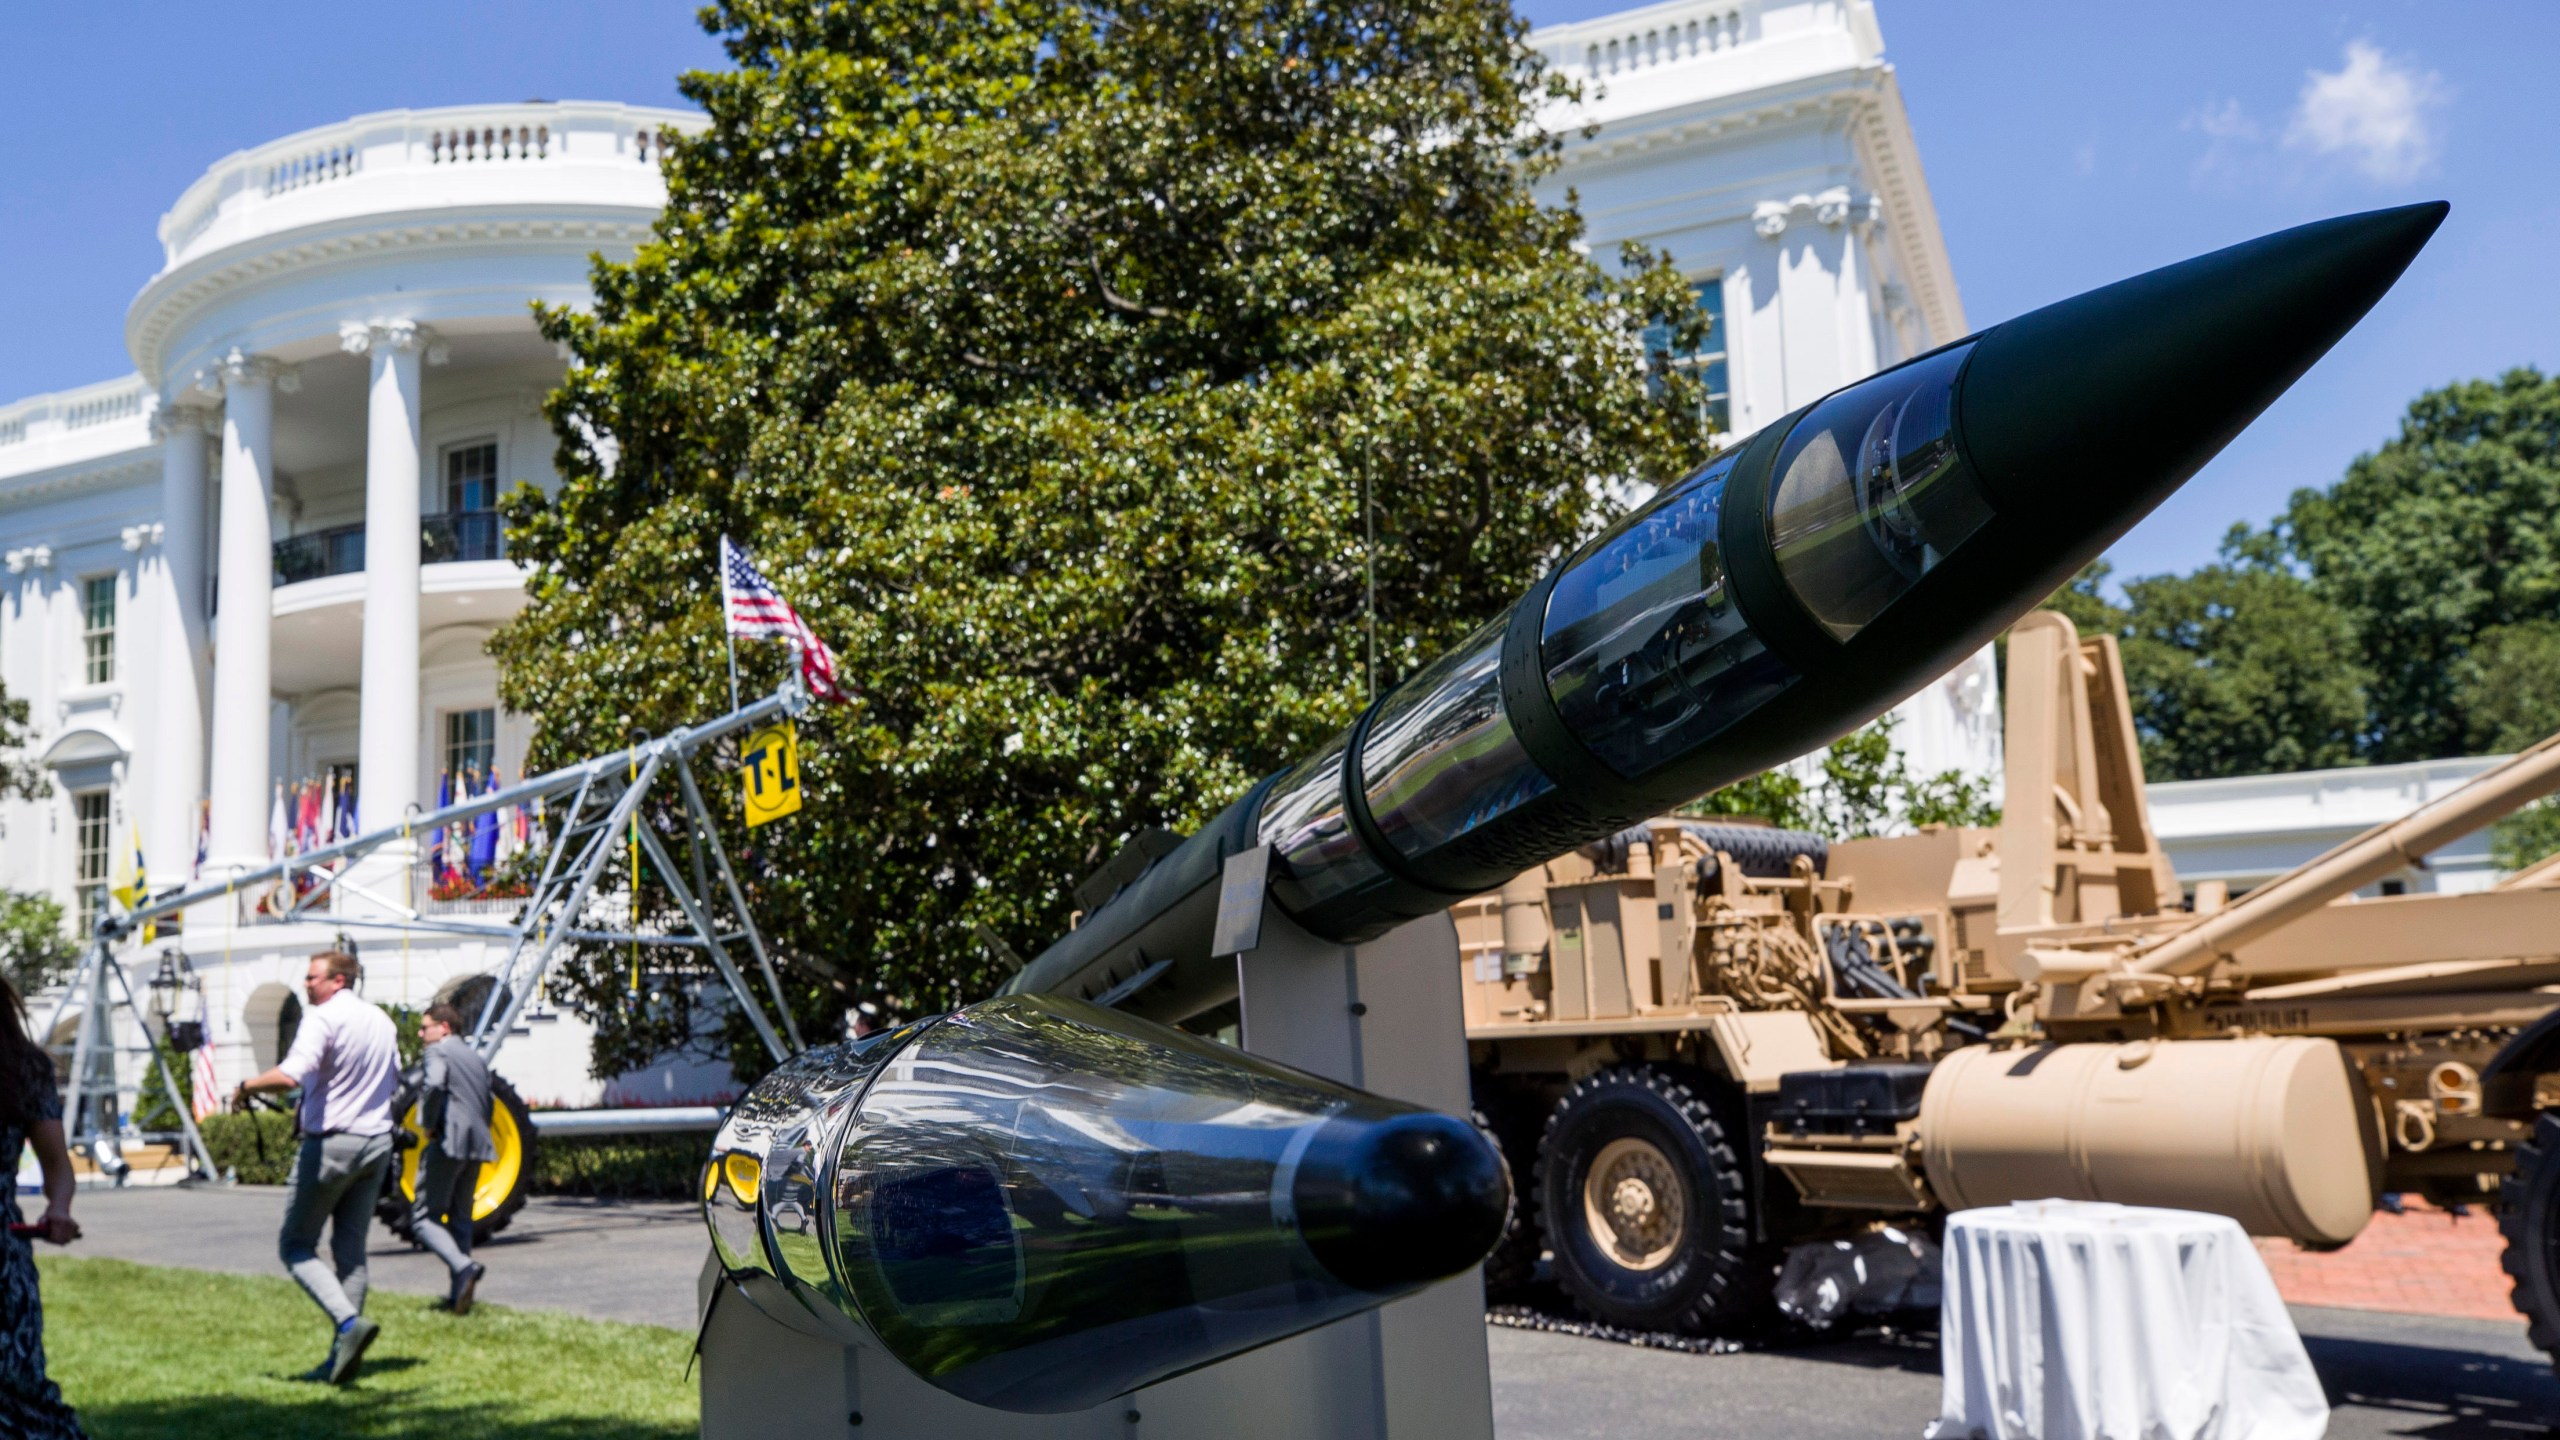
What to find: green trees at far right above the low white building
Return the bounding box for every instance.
[2051,369,2560,779]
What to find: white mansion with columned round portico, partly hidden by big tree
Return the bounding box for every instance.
[0,0,1999,1122]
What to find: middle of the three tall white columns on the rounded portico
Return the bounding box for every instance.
[205,351,282,871]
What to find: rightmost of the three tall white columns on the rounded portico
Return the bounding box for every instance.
[338,320,420,830]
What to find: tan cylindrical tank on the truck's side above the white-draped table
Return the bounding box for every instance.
[1920,1035,2381,1245]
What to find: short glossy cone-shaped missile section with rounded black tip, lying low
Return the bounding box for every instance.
[701,994,1510,1412]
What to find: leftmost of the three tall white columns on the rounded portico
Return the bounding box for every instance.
[141,405,212,884]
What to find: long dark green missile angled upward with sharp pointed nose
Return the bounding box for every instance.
[1006,202,2447,1020]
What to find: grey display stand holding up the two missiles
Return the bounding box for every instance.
[699,902,1492,1440]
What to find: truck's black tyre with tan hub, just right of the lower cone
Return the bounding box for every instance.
[1539,1066,1772,1330]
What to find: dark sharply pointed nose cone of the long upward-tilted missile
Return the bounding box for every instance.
[1958,202,2450,517]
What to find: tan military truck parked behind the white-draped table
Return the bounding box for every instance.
[1457,612,2560,1355]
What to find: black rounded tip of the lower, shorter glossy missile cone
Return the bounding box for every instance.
[1290,1112,1510,1291]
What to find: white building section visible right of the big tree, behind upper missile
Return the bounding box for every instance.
[1531,0,2002,797]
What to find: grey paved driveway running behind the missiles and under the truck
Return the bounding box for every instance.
[72,1186,2560,1440]
